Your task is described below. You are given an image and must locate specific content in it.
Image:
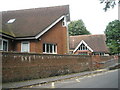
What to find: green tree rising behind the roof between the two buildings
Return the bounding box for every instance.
[68,20,90,36]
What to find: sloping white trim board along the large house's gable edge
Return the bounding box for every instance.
[35,16,64,39]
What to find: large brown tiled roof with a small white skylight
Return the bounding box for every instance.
[2,5,69,37]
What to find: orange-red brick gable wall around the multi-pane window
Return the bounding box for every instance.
[34,21,68,54]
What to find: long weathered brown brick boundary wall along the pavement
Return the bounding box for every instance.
[0,52,115,82]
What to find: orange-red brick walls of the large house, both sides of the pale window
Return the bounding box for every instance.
[11,20,68,54]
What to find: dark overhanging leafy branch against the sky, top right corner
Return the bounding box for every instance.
[100,0,120,11]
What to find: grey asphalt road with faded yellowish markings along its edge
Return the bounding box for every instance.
[29,70,120,88]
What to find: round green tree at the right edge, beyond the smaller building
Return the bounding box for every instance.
[105,20,120,54]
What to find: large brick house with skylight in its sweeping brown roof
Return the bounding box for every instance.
[0,5,70,54]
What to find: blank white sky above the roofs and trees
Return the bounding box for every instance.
[0,0,118,34]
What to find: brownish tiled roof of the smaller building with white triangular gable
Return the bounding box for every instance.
[70,34,108,52]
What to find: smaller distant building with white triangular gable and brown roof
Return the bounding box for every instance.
[69,34,109,55]
